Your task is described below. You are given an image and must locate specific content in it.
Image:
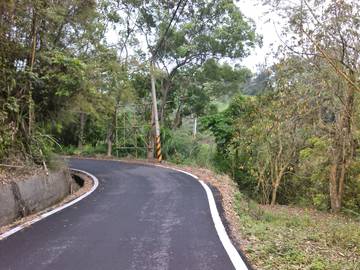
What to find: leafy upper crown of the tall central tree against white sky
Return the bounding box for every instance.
[140,0,257,61]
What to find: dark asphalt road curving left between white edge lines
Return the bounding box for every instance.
[0,160,239,270]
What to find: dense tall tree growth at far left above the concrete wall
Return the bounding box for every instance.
[0,0,104,161]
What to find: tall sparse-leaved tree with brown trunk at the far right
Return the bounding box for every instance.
[264,0,360,212]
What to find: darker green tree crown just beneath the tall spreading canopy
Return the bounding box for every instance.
[164,59,251,128]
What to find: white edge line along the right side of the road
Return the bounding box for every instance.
[155,165,248,270]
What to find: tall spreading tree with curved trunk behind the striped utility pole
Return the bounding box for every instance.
[115,0,258,122]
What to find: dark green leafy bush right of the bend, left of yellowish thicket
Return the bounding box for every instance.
[202,96,272,198]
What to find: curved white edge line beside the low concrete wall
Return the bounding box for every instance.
[0,168,99,240]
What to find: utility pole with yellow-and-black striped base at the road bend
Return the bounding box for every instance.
[150,59,162,162]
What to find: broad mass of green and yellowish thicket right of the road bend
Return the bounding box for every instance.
[202,53,360,215]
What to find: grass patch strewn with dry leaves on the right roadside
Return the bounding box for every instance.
[235,193,360,270]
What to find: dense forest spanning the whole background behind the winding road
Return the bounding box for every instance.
[0,0,360,215]
